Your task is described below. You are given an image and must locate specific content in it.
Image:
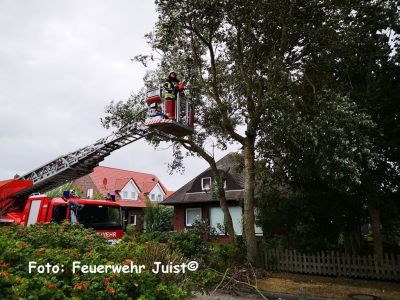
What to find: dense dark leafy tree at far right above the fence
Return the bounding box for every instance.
[256,1,400,257]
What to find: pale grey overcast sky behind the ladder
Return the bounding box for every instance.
[0,0,241,190]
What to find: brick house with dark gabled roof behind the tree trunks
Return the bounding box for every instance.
[162,153,262,241]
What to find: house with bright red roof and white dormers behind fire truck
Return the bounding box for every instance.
[72,166,172,230]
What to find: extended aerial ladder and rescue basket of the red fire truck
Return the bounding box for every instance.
[7,74,194,197]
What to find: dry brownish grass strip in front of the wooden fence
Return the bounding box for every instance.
[258,273,400,300]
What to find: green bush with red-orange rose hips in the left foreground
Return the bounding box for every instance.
[0,223,191,299]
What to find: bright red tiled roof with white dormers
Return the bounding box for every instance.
[89,166,169,200]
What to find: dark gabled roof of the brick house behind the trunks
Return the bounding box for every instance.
[161,153,244,205]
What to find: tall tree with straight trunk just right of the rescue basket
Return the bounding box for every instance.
[146,0,294,263]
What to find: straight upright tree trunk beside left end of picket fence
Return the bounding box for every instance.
[243,138,257,264]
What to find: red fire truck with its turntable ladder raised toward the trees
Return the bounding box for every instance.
[0,84,193,241]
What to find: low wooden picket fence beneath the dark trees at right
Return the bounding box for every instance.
[263,249,400,281]
